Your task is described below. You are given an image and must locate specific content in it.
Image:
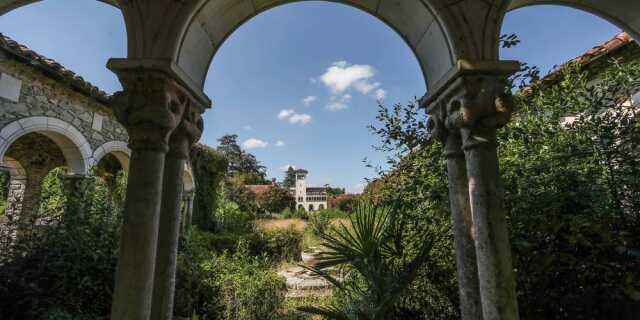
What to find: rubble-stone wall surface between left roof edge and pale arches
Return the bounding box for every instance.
[0,57,128,150]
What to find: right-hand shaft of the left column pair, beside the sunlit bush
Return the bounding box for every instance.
[151,105,202,320]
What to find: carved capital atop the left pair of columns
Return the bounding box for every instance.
[112,70,192,152]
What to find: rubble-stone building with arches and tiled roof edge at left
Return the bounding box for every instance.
[0,34,195,232]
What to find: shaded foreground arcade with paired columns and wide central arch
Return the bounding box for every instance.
[0,0,640,320]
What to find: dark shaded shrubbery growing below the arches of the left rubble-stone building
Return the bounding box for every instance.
[0,171,124,320]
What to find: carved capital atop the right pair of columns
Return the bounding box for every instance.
[422,62,517,155]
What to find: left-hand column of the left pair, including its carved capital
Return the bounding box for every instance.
[111,67,187,320]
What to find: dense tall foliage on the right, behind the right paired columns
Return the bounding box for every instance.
[362,62,640,319]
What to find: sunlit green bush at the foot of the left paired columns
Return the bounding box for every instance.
[175,233,286,320]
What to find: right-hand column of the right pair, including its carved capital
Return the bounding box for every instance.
[424,61,519,320]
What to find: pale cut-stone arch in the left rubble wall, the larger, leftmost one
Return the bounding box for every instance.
[0,117,92,175]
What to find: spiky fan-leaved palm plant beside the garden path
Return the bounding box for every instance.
[299,203,433,320]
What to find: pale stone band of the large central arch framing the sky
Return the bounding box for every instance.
[176,0,456,88]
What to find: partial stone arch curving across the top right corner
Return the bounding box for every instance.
[509,0,640,41]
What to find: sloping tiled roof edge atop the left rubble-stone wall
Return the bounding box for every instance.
[0,33,109,104]
